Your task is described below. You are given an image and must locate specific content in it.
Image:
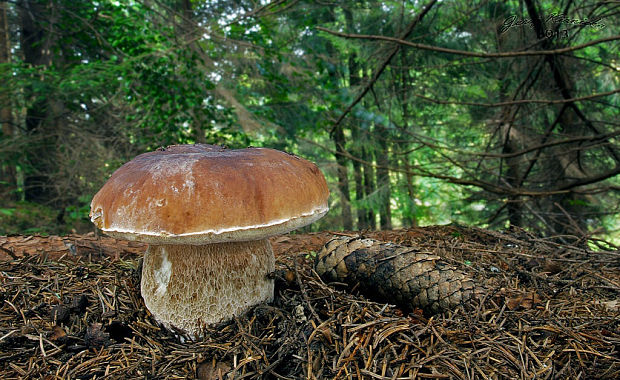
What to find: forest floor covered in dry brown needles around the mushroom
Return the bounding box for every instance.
[0,226,620,379]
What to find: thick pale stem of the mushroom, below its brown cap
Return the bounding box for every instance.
[141,239,275,337]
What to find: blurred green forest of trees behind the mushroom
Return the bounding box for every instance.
[0,0,620,245]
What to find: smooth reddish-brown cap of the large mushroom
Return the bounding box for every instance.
[91,144,329,244]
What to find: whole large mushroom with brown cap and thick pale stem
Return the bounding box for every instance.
[90,144,329,337]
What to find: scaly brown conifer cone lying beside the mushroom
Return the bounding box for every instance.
[314,236,475,315]
